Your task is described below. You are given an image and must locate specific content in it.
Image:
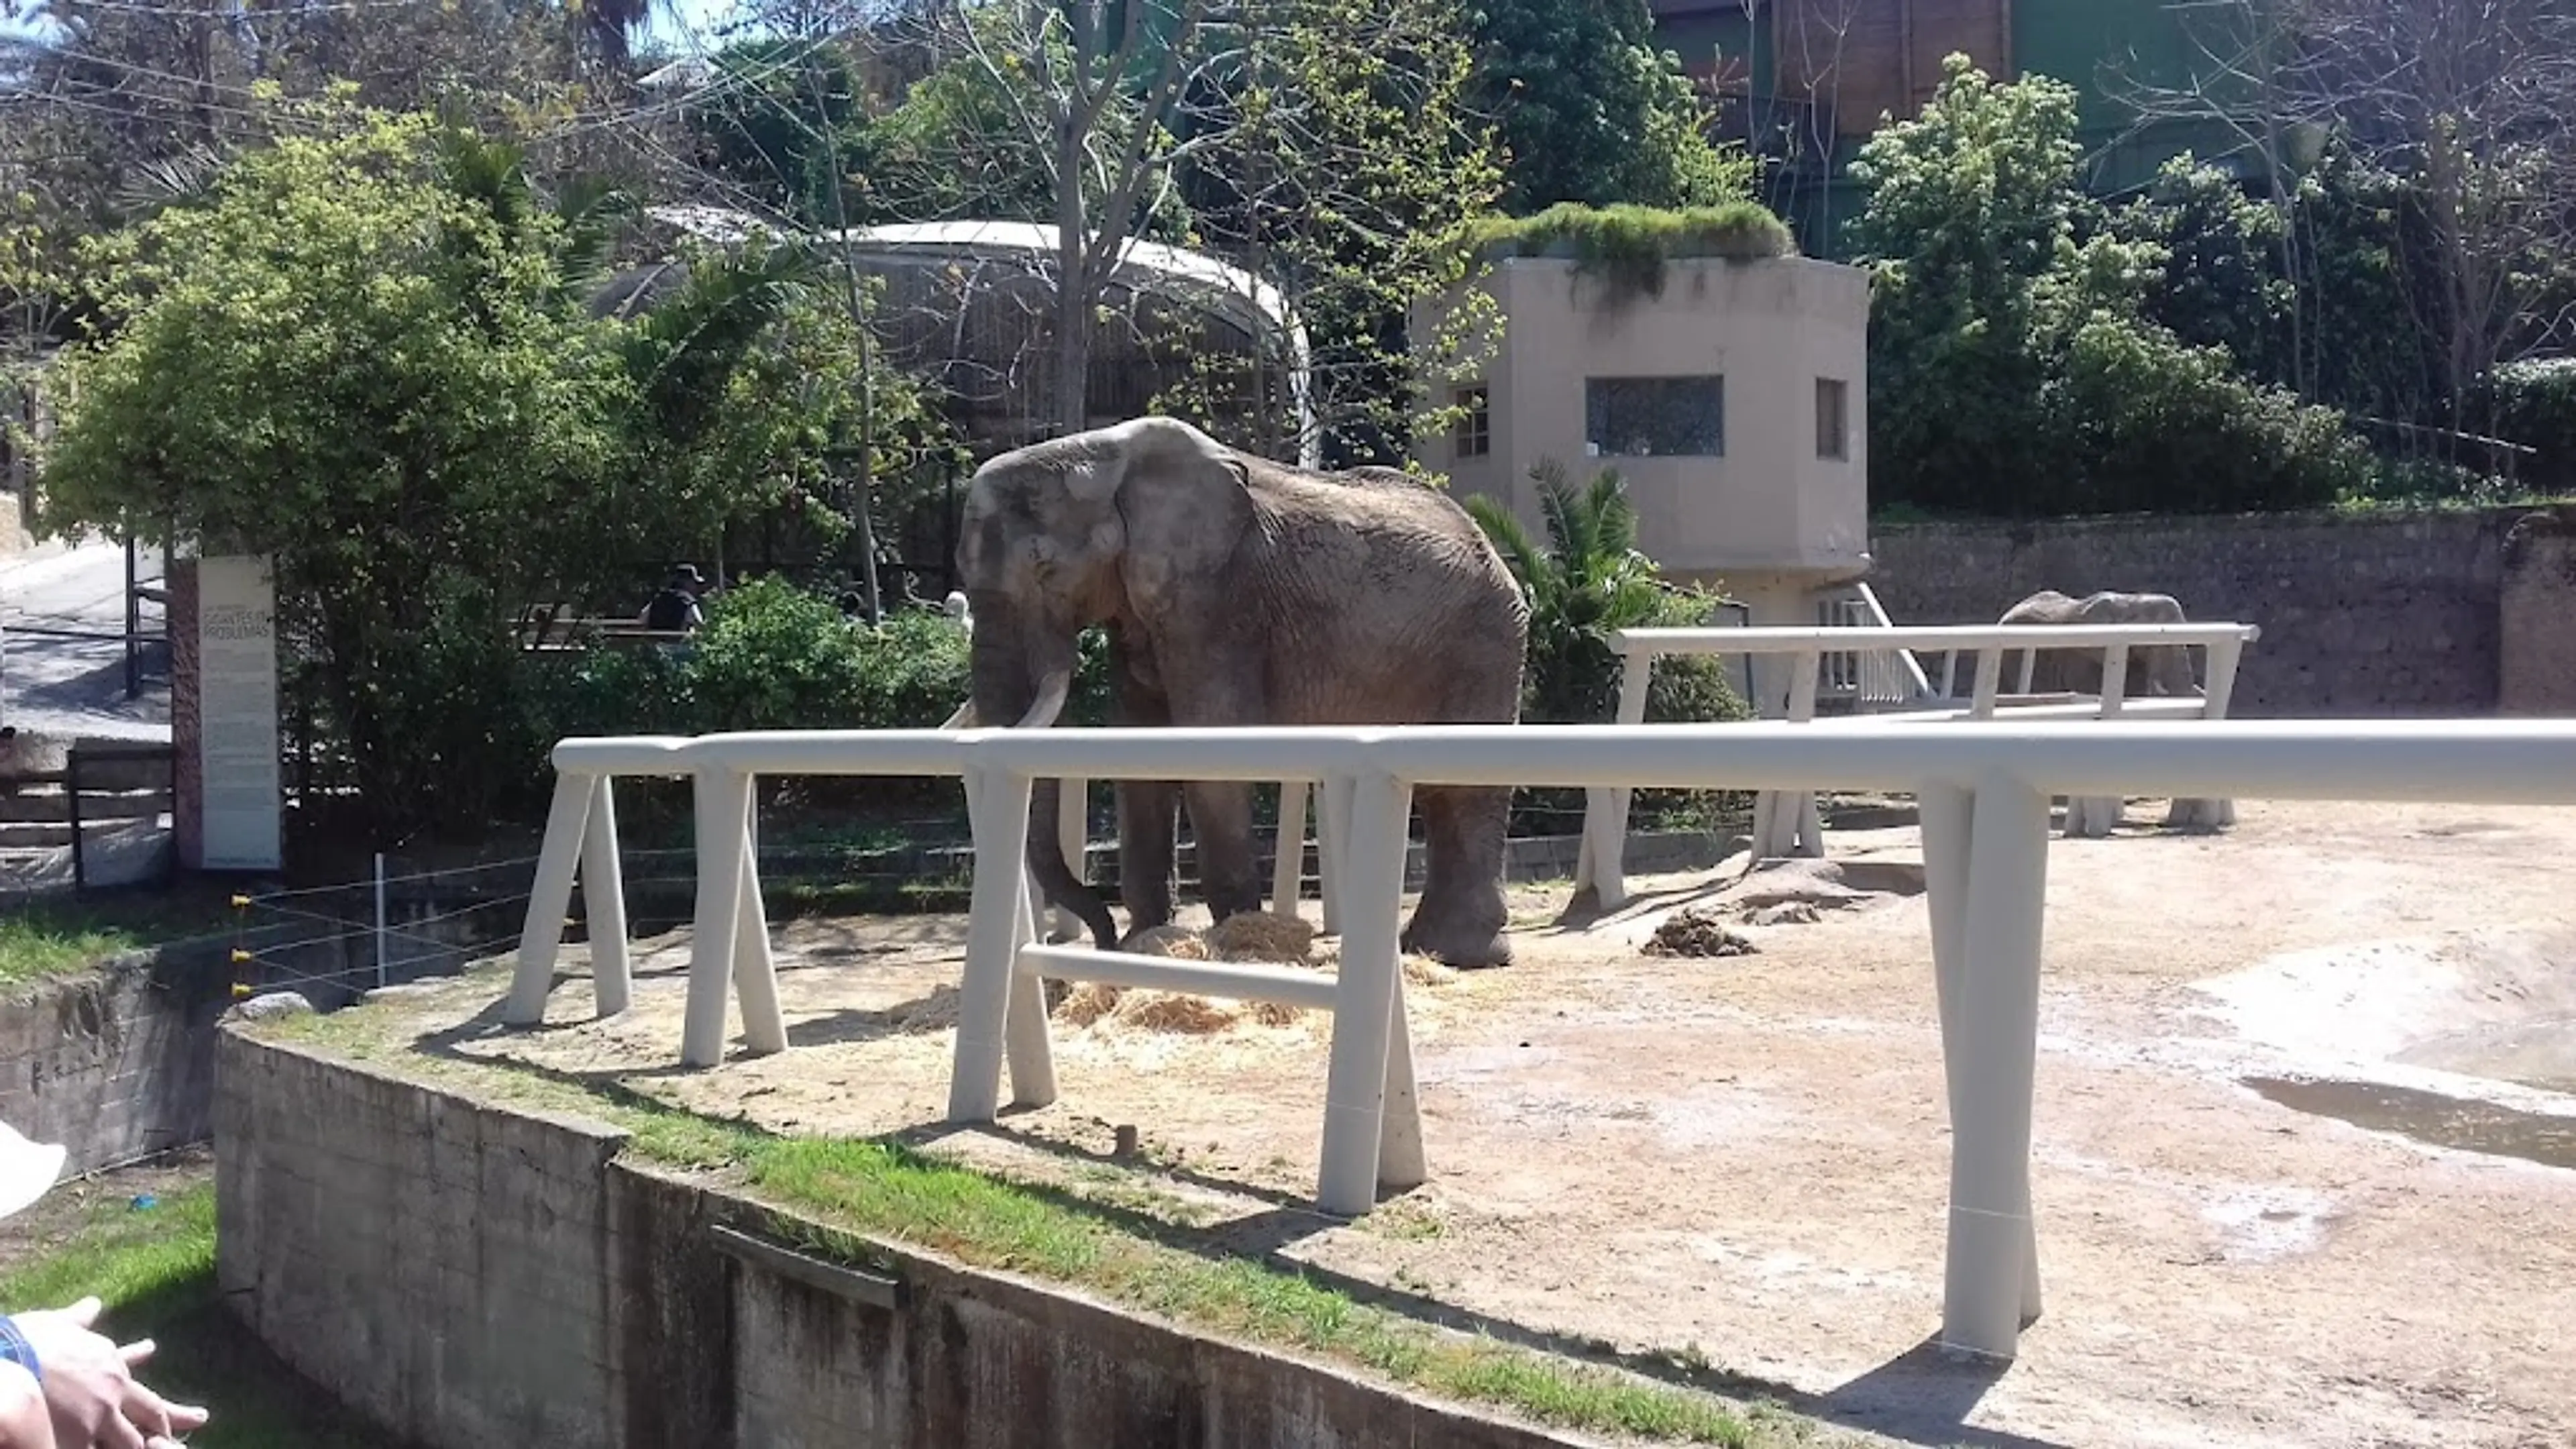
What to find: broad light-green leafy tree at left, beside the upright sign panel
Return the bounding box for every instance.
[44,111,875,830]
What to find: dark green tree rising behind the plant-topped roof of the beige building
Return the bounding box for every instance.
[1473,0,1752,214]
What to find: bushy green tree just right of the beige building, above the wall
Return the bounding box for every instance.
[1852,57,2367,516]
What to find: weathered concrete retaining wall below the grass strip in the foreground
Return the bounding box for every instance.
[217,1029,1589,1449]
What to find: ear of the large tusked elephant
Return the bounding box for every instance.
[1116,418,1252,619]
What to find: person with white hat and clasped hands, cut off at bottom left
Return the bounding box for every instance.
[0,1124,209,1449]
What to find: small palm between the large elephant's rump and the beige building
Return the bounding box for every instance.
[1466,459,1664,724]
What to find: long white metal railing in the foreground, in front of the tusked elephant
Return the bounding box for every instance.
[505,719,2576,1356]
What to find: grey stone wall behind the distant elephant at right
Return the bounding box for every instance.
[1870,508,2576,716]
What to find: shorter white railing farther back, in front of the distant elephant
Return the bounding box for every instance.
[1574,624,2262,910]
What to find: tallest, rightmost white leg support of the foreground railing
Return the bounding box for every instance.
[1924,773,2048,1358]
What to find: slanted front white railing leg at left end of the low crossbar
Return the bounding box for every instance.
[948,768,1030,1122]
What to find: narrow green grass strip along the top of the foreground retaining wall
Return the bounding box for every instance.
[260,1008,1819,1449]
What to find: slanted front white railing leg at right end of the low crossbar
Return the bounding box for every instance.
[1316,773,1411,1217]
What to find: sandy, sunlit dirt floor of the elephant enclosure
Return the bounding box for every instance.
[363,802,2576,1446]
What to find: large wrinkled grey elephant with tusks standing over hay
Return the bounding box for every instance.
[958,418,1527,967]
